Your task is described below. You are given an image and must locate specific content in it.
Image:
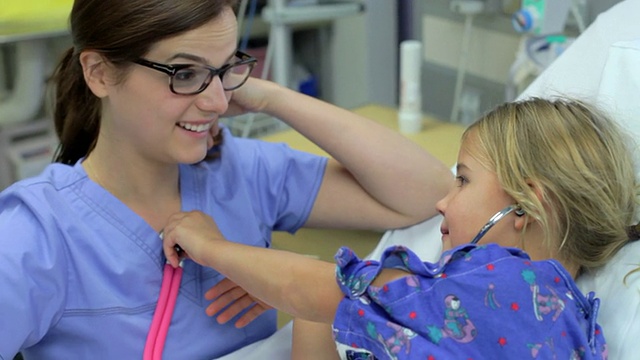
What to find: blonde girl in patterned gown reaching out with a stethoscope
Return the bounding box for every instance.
[164,99,636,359]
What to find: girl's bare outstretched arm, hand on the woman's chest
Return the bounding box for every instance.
[163,211,343,324]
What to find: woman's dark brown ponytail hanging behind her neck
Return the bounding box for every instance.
[53,47,101,165]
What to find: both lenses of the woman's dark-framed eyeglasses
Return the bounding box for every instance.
[172,63,253,94]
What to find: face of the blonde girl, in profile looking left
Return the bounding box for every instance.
[436,136,520,250]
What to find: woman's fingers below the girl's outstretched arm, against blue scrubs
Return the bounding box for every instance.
[204,278,273,328]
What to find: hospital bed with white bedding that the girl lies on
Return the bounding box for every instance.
[216,0,640,360]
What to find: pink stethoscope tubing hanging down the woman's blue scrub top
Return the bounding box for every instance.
[143,231,183,360]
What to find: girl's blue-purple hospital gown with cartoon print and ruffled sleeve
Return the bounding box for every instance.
[333,244,607,360]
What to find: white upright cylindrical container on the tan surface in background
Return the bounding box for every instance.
[398,40,422,133]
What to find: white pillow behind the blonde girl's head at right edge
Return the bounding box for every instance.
[578,37,640,359]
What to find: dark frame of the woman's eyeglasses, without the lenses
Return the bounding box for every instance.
[132,50,258,95]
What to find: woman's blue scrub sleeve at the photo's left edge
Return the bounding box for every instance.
[0,194,67,359]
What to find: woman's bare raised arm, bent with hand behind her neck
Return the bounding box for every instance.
[230,78,453,229]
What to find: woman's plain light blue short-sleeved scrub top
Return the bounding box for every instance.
[0,129,327,359]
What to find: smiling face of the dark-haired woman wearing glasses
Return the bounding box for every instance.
[100,9,237,164]
